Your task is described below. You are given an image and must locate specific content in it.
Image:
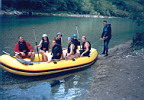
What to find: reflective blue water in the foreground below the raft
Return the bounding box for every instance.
[0,65,93,100]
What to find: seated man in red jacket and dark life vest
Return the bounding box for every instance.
[14,36,35,61]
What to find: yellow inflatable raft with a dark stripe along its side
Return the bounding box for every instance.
[0,48,98,76]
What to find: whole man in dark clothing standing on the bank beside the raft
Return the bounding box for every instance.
[100,21,112,57]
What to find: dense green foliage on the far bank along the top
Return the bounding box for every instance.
[2,0,144,23]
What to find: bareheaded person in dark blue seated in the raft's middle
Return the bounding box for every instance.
[48,39,62,62]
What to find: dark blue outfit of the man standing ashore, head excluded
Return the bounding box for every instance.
[101,24,112,55]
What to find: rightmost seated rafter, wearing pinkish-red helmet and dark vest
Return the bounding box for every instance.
[80,36,91,57]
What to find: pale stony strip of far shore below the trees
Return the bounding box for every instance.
[0,10,124,18]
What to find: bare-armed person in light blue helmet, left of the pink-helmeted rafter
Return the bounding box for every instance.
[65,37,79,59]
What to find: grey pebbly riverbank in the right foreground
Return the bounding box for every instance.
[85,42,144,100]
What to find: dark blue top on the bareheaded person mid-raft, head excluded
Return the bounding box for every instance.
[52,44,62,59]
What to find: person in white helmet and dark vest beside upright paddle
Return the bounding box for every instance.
[38,34,50,61]
